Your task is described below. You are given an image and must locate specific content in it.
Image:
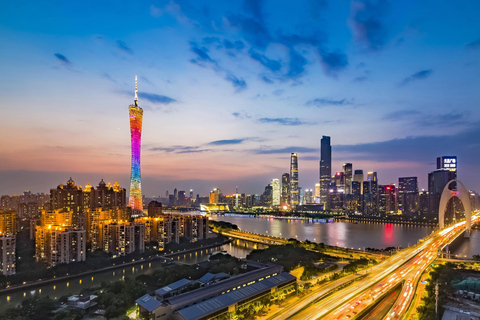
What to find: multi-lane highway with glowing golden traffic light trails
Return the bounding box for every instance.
[271,215,479,320]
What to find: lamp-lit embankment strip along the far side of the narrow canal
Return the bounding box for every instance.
[0,240,230,295]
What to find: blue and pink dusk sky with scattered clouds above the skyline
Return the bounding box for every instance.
[0,0,480,196]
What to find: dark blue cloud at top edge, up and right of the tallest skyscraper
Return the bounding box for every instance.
[350,0,390,51]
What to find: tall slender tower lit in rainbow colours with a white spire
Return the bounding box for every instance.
[128,76,143,214]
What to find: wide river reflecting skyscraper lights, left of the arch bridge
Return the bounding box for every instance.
[212,215,433,249]
